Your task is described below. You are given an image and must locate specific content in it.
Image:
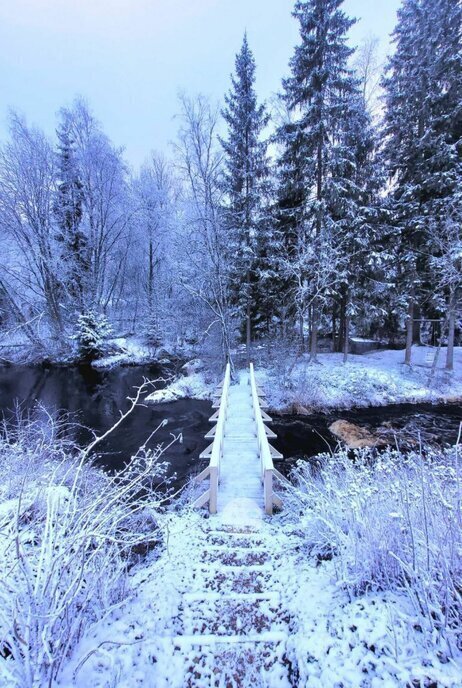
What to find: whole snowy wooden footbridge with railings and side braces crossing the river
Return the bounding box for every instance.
[194,363,285,520]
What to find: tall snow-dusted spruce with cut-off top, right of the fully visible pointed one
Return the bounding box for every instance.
[280,0,355,360]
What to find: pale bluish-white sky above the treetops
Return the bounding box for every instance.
[0,0,400,166]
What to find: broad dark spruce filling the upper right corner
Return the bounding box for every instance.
[384,0,462,363]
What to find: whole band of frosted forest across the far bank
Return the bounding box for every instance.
[0,0,462,370]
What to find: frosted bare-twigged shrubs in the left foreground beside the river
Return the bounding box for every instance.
[0,412,168,688]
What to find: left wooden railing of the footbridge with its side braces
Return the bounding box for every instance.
[193,363,231,514]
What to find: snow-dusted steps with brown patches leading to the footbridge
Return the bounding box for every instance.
[150,520,289,688]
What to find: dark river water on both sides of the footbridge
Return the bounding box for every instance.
[0,365,462,487]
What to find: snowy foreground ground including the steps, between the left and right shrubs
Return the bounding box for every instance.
[60,512,462,688]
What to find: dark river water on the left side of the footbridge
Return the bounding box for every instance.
[0,365,211,485]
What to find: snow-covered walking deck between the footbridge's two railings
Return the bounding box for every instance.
[218,371,264,523]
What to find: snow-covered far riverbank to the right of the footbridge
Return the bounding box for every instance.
[256,346,462,412]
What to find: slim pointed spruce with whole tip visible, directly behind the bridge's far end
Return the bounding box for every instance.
[222,35,270,356]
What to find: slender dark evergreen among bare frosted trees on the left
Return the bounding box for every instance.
[54,116,89,312]
